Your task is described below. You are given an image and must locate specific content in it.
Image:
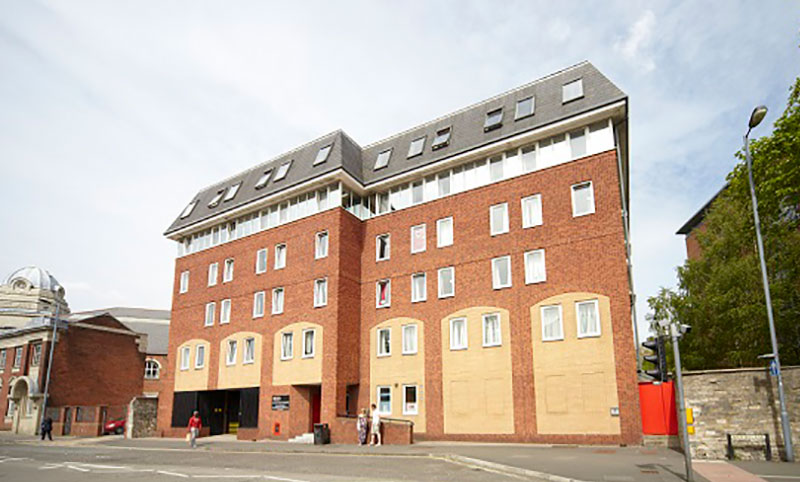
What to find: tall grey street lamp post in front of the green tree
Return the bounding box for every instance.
[744,105,794,462]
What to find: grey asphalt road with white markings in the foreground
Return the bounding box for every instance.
[0,444,514,482]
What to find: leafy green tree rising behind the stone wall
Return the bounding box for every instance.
[648,78,800,369]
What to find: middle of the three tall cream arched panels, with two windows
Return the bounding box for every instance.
[441,306,514,434]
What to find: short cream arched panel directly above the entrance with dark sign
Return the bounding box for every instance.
[272,322,323,386]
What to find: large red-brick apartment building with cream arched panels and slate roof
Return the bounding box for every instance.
[158,62,641,444]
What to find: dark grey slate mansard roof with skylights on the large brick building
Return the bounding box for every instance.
[165,62,627,234]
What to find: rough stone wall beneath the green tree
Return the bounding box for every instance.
[683,366,800,460]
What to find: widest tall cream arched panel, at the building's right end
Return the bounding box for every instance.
[531,293,620,435]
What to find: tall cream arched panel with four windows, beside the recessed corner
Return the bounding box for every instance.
[370,317,425,433]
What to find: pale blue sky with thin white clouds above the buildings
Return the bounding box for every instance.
[0,0,800,338]
